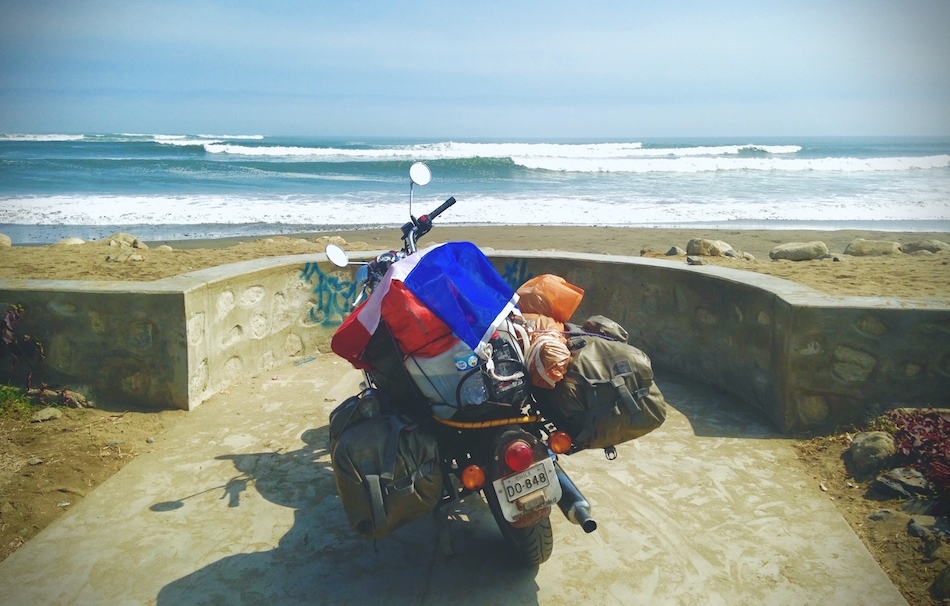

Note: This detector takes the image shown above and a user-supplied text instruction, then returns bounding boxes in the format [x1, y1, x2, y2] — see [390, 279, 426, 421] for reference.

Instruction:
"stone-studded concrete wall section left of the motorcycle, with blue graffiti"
[0, 255, 355, 410]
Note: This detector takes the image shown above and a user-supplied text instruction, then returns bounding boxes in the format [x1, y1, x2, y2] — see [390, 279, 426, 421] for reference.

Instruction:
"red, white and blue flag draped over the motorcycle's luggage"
[330, 242, 518, 368]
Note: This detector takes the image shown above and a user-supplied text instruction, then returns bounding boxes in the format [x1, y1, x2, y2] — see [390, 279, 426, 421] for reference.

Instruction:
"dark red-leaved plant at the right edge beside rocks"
[885, 408, 950, 499]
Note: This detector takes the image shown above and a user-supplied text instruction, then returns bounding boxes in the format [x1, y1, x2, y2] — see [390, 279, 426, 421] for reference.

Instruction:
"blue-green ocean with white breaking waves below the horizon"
[0, 134, 950, 244]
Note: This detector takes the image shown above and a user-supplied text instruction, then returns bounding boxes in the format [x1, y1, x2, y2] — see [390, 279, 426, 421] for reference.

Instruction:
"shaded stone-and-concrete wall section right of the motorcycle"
[491, 251, 950, 431]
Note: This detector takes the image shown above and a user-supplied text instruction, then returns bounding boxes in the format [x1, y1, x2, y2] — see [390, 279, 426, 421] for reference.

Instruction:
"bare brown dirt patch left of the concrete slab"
[0, 408, 187, 561]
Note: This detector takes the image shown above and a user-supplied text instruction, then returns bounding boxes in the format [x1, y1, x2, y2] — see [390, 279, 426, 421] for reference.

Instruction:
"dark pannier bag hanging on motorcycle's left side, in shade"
[330, 391, 443, 539]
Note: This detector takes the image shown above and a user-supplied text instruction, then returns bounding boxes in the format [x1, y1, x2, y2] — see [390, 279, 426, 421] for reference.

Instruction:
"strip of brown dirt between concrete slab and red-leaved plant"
[795, 433, 950, 606]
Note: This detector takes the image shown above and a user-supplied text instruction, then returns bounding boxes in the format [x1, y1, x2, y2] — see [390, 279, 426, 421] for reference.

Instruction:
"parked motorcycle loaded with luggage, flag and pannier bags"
[327, 162, 665, 565]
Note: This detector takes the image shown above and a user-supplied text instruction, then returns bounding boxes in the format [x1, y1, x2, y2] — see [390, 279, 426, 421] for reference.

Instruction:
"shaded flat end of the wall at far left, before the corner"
[0, 280, 188, 408]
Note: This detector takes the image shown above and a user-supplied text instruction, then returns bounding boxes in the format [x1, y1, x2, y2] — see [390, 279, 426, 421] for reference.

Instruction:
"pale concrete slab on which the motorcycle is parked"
[0, 356, 906, 606]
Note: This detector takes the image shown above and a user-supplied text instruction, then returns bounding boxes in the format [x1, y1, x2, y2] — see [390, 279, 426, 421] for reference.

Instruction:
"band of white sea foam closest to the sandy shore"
[0, 193, 950, 226]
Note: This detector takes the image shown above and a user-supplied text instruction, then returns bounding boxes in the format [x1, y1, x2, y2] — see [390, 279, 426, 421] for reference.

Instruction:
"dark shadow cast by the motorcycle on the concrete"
[156, 427, 538, 605]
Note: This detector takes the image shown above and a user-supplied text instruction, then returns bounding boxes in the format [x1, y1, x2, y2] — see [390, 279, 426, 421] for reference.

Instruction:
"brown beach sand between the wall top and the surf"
[0, 226, 950, 298]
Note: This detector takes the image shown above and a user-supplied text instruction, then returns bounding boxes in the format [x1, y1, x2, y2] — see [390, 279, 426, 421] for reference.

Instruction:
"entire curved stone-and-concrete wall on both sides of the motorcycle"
[0, 251, 950, 431]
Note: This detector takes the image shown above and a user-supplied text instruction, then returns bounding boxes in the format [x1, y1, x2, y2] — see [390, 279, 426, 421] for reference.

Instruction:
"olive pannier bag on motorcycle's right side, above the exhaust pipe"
[533, 325, 666, 450]
